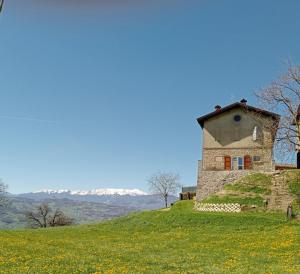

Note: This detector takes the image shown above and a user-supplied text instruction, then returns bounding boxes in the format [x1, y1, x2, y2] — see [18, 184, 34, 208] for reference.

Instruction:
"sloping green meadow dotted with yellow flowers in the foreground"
[0, 202, 300, 273]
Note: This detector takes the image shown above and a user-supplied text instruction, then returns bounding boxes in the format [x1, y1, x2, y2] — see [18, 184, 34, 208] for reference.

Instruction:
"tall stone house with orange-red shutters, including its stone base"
[197, 99, 280, 201]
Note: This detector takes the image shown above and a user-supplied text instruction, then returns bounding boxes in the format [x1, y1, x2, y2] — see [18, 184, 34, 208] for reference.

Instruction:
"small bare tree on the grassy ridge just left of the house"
[148, 171, 180, 208]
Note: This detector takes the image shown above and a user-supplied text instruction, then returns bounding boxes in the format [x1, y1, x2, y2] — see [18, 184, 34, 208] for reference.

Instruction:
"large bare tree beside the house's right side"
[255, 66, 300, 162]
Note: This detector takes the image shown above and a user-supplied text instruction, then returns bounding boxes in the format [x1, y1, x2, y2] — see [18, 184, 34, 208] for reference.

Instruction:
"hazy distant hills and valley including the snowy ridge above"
[0, 188, 177, 229]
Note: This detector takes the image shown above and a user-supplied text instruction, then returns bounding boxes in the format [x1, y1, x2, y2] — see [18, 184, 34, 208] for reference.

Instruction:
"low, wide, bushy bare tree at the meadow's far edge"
[26, 203, 73, 228]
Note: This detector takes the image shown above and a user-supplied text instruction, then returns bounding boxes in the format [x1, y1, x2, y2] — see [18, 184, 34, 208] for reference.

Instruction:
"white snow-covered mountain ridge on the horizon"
[33, 188, 148, 196]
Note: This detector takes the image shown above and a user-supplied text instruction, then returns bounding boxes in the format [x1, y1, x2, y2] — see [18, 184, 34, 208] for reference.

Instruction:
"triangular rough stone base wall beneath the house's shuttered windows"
[196, 170, 253, 201]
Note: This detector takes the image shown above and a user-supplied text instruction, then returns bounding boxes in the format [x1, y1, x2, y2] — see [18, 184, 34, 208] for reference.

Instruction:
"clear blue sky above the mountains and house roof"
[0, 0, 300, 193]
